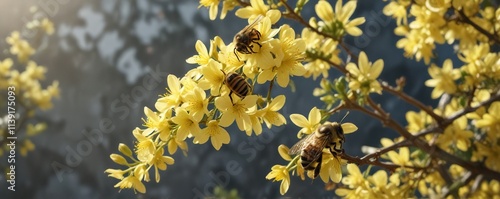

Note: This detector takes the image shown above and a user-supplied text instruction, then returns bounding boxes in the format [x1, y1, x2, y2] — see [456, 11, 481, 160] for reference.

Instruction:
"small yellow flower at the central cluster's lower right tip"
[259, 95, 286, 129]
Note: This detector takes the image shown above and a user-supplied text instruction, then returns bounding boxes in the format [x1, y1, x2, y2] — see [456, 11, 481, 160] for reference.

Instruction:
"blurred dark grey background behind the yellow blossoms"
[0, 0, 438, 199]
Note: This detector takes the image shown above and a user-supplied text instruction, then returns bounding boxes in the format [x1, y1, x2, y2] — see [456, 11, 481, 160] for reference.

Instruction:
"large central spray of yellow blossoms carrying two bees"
[106, 1, 305, 193]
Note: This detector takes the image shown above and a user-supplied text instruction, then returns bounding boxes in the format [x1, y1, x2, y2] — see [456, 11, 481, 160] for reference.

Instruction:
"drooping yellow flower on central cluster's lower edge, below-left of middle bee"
[193, 120, 231, 150]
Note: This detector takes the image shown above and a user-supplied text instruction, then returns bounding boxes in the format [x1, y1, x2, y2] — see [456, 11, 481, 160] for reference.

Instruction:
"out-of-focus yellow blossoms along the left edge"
[0, 18, 59, 159]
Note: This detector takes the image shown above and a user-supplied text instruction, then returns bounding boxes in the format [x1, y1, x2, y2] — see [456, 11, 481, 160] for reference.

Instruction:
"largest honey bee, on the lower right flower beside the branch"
[288, 122, 345, 178]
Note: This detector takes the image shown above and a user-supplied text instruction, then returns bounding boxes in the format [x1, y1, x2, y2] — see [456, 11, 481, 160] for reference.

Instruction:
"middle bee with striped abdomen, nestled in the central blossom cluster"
[222, 71, 252, 102]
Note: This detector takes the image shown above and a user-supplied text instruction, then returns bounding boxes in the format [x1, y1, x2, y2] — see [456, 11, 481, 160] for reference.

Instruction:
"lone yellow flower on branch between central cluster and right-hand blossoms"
[346, 52, 384, 95]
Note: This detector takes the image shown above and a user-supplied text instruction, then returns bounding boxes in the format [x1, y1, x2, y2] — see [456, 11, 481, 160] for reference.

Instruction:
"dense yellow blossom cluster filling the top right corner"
[383, 0, 500, 64]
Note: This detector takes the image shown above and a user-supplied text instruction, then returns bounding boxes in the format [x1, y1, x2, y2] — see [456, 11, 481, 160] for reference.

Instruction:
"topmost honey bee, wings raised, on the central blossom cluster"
[233, 15, 263, 61]
